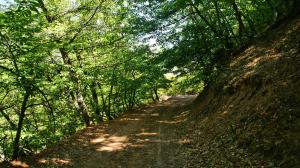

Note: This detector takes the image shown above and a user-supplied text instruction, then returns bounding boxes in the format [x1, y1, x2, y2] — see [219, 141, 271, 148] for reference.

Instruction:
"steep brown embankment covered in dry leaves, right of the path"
[186, 17, 300, 167]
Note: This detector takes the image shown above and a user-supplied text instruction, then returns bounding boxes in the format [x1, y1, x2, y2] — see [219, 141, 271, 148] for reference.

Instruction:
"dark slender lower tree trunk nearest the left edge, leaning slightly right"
[12, 91, 31, 160]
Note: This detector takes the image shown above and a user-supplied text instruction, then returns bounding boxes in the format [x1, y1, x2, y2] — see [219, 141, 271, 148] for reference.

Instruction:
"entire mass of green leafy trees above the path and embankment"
[0, 0, 298, 159]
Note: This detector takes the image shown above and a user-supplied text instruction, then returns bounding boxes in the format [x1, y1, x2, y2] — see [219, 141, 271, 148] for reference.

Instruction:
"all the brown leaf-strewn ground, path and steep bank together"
[4, 13, 300, 168]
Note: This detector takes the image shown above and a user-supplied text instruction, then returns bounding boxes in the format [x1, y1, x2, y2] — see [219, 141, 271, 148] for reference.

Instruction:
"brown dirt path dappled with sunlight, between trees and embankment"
[17, 96, 195, 168]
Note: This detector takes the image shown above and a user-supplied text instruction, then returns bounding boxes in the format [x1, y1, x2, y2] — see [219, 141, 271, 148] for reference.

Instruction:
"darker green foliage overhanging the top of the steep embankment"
[133, 0, 299, 85]
